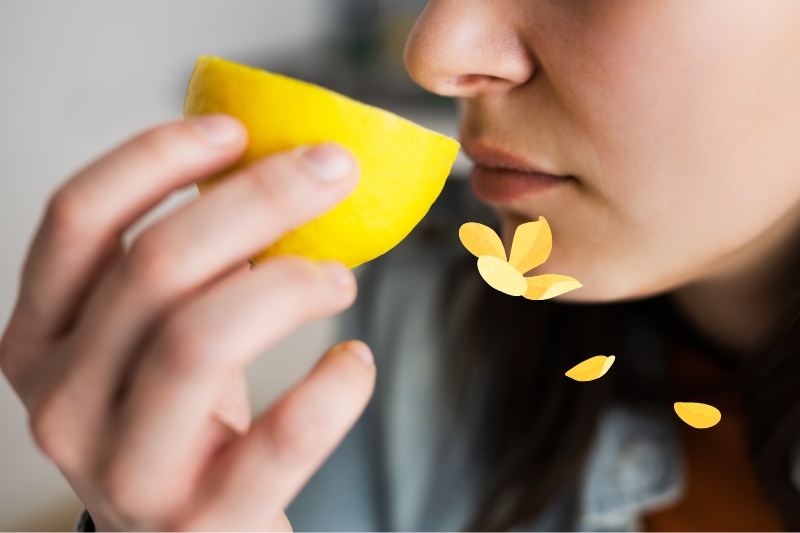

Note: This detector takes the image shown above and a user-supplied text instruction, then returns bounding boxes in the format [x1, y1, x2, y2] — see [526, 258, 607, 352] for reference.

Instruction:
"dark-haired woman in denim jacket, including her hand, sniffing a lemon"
[0, 0, 800, 530]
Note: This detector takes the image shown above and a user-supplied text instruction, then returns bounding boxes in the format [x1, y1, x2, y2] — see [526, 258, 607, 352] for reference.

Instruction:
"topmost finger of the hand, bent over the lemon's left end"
[12, 115, 247, 338]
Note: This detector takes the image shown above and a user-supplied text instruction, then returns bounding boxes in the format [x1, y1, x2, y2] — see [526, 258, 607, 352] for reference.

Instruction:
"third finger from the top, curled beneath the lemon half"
[100, 257, 355, 514]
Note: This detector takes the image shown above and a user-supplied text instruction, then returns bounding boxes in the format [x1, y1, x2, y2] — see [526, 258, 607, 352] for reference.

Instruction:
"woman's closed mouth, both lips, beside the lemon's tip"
[463, 143, 575, 204]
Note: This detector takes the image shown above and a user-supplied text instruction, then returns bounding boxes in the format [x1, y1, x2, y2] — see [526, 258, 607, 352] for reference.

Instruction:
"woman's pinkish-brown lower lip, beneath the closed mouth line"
[469, 165, 570, 204]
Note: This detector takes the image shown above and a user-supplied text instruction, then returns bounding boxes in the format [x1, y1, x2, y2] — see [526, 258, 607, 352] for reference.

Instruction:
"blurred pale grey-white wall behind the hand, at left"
[0, 0, 335, 530]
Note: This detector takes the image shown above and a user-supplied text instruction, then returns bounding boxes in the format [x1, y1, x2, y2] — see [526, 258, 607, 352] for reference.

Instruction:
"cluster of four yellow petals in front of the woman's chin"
[458, 217, 583, 300]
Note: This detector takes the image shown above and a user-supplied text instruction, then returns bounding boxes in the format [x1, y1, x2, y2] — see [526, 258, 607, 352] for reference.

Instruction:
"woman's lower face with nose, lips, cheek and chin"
[406, 0, 800, 301]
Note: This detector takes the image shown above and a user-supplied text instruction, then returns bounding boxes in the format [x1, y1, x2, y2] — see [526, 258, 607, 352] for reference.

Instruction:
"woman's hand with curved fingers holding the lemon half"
[0, 115, 375, 530]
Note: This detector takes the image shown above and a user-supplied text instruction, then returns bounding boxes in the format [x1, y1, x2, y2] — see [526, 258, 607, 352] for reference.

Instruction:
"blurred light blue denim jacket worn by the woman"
[287, 182, 800, 531]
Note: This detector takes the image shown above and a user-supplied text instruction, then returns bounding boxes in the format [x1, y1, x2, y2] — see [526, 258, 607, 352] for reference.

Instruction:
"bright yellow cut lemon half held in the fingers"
[184, 56, 459, 268]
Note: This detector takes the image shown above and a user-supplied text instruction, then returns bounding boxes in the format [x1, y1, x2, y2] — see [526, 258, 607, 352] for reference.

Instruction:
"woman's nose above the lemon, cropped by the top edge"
[405, 0, 536, 97]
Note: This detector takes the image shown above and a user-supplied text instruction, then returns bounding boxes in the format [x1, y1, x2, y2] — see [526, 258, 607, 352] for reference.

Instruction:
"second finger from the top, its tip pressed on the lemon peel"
[42, 144, 358, 458]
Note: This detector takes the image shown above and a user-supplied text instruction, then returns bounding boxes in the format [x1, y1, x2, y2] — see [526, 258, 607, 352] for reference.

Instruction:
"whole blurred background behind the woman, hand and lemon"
[0, 0, 466, 531]
